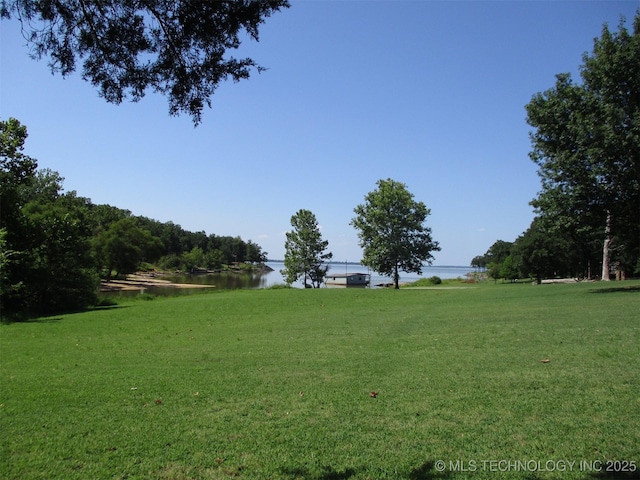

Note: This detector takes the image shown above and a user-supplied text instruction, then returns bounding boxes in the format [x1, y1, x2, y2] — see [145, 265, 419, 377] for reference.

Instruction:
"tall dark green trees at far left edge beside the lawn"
[0, 118, 98, 319]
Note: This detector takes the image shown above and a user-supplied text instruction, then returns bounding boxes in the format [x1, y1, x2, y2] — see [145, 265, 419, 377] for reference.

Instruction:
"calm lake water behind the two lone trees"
[160, 262, 474, 293]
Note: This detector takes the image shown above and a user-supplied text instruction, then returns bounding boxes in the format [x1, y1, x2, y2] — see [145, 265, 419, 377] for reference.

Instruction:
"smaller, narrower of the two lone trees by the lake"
[281, 209, 333, 288]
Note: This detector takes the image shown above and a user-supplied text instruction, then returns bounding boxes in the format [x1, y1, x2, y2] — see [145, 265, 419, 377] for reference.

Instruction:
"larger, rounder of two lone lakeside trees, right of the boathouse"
[351, 179, 440, 288]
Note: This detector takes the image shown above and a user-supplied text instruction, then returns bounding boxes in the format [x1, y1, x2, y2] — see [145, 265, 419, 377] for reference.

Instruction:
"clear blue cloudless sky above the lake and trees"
[0, 0, 640, 265]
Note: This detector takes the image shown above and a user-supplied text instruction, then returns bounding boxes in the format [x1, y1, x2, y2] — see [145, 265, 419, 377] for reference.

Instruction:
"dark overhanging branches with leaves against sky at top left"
[0, 0, 289, 124]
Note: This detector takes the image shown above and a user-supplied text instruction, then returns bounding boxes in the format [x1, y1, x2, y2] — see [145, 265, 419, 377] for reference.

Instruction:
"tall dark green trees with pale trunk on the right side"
[472, 12, 640, 281]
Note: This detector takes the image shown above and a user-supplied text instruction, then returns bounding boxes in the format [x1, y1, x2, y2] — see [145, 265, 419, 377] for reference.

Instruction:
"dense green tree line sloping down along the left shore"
[0, 118, 267, 319]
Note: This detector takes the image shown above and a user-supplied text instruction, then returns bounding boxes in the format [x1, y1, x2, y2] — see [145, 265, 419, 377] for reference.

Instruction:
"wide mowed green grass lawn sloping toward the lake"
[0, 282, 640, 480]
